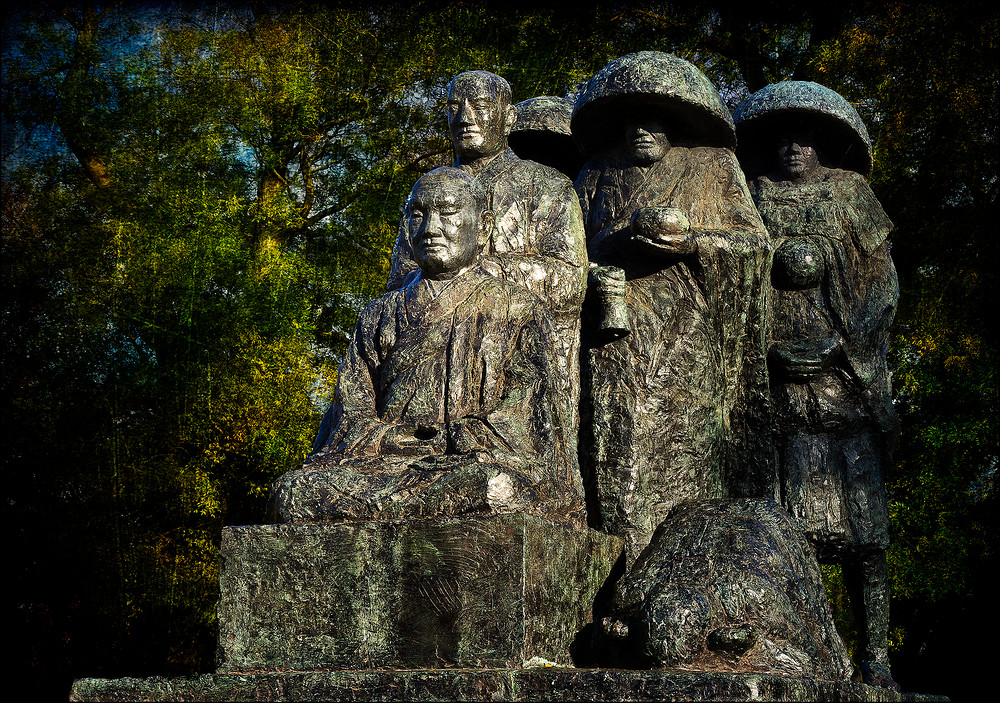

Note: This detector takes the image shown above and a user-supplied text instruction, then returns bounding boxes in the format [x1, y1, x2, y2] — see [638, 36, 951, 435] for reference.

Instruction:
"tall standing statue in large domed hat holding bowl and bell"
[572, 52, 769, 561]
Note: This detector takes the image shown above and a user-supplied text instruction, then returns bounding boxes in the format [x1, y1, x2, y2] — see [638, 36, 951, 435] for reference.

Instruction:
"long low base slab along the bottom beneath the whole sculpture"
[70, 668, 948, 703]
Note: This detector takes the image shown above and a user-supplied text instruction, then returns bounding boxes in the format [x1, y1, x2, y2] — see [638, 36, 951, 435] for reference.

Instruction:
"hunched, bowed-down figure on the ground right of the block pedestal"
[605, 500, 852, 681]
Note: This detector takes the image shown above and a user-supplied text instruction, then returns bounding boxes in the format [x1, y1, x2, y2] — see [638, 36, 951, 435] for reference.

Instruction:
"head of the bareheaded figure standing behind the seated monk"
[448, 73, 517, 159]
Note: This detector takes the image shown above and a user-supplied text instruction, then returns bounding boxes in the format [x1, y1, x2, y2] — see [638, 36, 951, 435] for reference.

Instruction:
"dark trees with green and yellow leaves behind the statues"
[0, 0, 1000, 700]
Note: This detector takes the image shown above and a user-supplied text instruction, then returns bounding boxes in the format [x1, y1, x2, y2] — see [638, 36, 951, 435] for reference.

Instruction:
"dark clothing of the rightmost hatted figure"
[751, 167, 899, 557]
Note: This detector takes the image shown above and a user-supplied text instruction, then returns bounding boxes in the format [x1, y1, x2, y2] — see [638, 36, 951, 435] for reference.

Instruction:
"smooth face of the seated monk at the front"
[407, 174, 480, 279]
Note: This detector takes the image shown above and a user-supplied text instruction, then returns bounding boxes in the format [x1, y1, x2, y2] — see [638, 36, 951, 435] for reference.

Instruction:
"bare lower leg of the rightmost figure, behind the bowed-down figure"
[844, 550, 899, 690]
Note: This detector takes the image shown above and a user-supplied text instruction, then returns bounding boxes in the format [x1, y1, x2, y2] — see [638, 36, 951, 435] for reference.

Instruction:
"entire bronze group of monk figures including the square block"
[68, 52, 898, 695]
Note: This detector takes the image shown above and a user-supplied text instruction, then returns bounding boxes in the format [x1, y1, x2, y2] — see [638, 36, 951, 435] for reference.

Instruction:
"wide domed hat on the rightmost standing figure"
[734, 81, 872, 177]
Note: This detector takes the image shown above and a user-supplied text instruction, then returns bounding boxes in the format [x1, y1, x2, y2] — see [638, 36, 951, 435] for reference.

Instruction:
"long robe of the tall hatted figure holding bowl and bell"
[576, 147, 774, 560]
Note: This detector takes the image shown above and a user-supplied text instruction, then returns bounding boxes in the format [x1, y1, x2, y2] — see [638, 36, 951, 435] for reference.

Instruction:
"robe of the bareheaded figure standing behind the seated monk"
[386, 149, 587, 446]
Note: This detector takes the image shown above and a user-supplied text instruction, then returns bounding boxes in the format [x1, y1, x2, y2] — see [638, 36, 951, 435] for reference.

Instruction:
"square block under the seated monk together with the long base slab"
[70, 515, 948, 702]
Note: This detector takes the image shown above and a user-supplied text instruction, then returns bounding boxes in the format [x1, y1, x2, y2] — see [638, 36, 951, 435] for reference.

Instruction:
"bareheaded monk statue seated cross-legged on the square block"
[268, 168, 585, 526]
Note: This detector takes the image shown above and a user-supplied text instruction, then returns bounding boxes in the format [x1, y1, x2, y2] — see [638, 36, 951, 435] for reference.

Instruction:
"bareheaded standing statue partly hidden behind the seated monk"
[387, 71, 587, 456]
